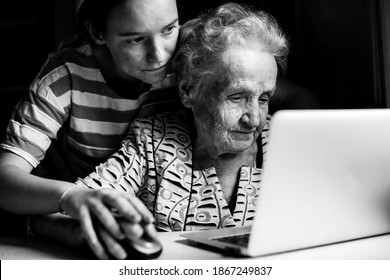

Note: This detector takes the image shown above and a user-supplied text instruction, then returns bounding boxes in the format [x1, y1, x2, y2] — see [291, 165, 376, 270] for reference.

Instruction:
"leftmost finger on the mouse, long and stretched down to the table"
[80, 206, 108, 259]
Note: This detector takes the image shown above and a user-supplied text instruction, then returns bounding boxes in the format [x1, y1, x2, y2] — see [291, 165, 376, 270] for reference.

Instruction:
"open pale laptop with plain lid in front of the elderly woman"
[181, 109, 390, 257]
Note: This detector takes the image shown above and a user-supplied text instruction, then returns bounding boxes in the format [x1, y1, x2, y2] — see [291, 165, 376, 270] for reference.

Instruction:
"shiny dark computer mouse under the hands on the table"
[119, 233, 163, 260]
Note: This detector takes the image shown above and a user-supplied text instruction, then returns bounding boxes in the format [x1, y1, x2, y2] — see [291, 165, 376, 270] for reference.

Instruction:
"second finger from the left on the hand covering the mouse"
[88, 200, 125, 239]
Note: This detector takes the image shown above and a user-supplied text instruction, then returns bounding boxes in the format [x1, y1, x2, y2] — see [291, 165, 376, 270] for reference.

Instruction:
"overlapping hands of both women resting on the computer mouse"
[61, 187, 155, 259]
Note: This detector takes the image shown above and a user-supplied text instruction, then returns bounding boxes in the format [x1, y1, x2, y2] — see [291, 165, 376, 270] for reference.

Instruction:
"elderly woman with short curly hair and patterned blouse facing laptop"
[74, 3, 288, 231]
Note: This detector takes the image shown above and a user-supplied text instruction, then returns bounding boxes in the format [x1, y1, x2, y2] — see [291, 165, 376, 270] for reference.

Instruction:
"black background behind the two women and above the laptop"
[0, 0, 389, 136]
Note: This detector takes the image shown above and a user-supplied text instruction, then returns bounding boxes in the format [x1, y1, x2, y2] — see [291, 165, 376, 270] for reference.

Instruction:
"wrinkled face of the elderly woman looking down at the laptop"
[193, 41, 277, 156]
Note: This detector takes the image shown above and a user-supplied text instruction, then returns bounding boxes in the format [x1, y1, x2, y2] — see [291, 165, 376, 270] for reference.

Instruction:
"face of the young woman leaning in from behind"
[103, 0, 179, 84]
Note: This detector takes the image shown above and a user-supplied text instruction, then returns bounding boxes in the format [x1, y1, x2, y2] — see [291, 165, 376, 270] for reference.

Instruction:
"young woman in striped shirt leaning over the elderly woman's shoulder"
[0, 0, 179, 258]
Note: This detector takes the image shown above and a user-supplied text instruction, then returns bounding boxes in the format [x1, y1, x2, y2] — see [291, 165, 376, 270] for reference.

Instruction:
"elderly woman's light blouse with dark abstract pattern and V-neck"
[76, 111, 269, 231]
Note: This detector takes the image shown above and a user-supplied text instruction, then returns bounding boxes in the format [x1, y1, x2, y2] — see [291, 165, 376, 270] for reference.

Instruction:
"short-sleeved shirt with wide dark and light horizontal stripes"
[1, 45, 177, 177]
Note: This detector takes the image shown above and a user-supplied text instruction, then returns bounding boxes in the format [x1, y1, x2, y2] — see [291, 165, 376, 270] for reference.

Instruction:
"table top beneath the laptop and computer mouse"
[0, 232, 390, 260]
